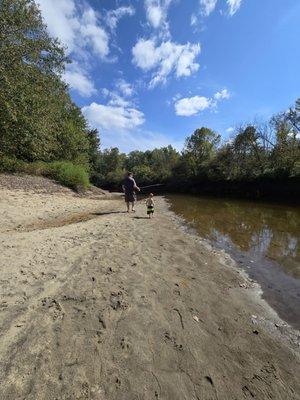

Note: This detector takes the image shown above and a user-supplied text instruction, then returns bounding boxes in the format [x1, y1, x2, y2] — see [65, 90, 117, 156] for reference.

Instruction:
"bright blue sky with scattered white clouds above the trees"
[36, 0, 300, 152]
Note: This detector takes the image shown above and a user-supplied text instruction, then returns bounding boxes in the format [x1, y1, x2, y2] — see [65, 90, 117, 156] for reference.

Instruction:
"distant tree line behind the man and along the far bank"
[92, 99, 300, 192]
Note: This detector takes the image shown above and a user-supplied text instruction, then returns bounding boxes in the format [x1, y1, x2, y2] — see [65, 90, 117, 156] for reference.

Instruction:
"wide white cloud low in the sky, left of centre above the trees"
[82, 102, 145, 132]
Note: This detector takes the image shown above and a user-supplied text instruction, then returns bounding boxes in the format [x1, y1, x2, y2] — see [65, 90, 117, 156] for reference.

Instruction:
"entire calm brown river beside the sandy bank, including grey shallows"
[167, 195, 300, 329]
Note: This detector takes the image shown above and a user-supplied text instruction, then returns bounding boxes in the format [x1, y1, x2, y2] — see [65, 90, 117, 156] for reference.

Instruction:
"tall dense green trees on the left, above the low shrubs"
[0, 0, 99, 167]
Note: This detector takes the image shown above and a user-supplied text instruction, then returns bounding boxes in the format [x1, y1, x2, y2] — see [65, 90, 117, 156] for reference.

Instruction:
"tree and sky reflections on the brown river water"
[170, 195, 300, 278]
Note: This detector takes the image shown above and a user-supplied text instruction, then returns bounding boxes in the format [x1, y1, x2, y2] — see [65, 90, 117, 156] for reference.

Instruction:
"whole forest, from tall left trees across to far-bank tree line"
[0, 0, 300, 197]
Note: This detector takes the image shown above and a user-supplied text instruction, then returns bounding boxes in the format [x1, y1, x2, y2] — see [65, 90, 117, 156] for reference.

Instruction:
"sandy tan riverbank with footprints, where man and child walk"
[0, 177, 300, 400]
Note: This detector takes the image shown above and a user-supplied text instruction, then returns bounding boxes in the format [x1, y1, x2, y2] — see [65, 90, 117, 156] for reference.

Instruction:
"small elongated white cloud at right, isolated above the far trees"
[175, 89, 230, 117]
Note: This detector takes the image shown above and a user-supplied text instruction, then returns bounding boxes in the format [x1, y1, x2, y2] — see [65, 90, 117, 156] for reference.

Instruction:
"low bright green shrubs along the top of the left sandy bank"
[0, 156, 90, 191]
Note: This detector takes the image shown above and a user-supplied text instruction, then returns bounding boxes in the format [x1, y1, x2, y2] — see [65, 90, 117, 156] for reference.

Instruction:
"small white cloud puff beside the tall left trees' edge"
[63, 63, 97, 97]
